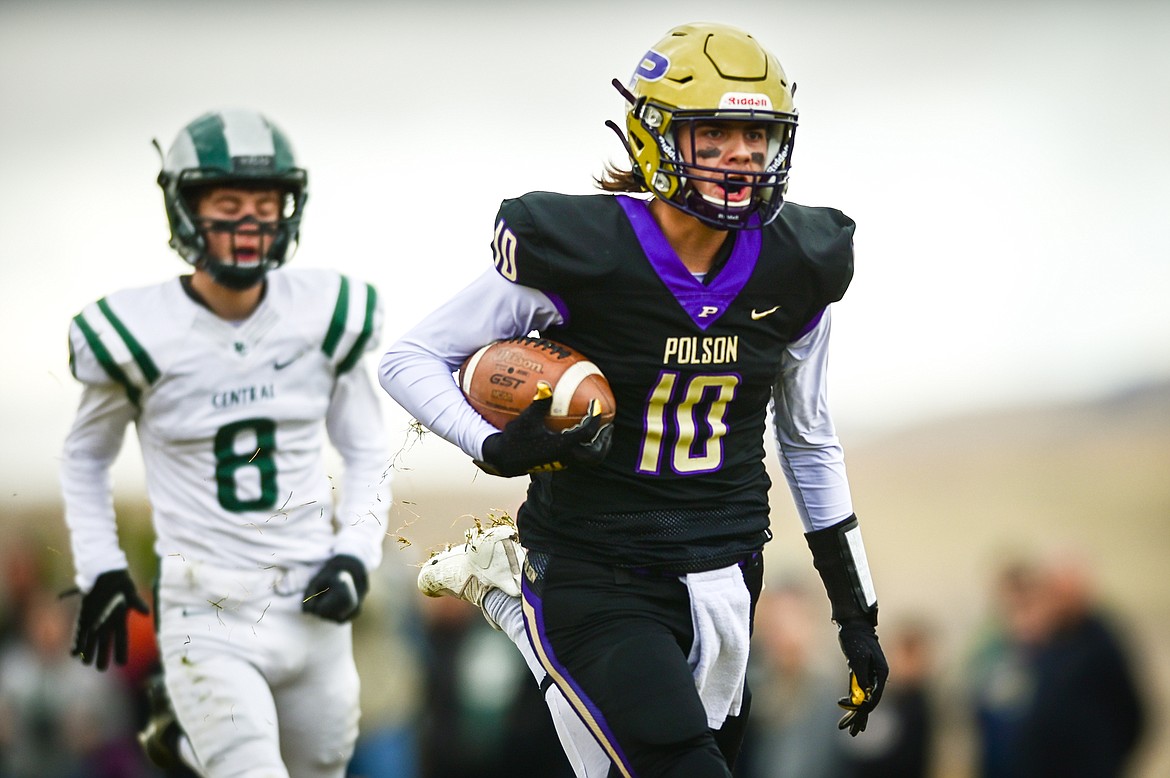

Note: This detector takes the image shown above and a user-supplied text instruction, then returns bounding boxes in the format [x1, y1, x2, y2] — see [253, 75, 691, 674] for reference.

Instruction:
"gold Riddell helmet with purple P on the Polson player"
[626, 23, 797, 229]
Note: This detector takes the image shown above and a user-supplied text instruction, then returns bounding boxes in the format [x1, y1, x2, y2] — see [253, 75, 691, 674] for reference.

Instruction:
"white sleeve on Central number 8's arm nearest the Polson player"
[325, 359, 391, 571]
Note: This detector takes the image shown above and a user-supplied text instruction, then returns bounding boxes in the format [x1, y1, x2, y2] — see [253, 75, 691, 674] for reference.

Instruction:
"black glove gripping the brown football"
[475, 381, 613, 477]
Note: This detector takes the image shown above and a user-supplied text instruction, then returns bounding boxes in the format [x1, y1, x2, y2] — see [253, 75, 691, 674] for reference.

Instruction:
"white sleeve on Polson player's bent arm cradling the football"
[378, 269, 563, 459]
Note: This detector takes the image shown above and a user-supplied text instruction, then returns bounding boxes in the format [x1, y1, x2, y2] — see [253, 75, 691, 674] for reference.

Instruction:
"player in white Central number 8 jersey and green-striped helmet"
[61, 110, 390, 778]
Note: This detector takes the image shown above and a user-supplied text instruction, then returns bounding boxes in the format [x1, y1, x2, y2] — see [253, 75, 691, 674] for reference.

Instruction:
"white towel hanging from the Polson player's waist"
[682, 565, 751, 729]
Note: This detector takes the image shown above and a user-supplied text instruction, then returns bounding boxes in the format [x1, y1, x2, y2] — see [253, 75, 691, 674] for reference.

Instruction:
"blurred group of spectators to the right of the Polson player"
[737, 552, 1149, 778]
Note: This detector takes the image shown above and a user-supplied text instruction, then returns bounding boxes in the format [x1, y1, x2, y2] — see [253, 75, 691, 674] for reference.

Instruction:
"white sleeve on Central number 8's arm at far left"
[61, 384, 137, 592]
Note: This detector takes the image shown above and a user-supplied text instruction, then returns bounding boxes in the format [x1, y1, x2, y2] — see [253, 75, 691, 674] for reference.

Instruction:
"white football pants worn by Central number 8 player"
[158, 557, 359, 778]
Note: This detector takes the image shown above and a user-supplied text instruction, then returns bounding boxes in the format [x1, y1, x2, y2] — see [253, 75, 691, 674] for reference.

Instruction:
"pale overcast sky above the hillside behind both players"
[0, 0, 1170, 496]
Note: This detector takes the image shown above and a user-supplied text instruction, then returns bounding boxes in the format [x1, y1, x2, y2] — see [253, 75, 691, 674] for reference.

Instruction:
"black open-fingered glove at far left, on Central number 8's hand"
[70, 570, 150, 670]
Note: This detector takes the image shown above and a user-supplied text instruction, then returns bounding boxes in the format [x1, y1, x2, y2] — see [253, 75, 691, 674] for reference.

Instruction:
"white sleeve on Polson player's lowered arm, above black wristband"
[772, 309, 853, 532]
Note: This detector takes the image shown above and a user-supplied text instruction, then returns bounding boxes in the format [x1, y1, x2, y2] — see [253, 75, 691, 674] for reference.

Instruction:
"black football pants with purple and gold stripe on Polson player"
[524, 555, 763, 778]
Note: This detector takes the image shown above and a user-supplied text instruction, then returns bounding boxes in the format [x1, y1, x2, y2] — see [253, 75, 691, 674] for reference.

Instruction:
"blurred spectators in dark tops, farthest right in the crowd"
[968, 551, 1149, 777]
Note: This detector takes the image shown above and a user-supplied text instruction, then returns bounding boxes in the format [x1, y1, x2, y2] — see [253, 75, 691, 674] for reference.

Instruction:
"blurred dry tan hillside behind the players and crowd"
[0, 385, 1170, 778]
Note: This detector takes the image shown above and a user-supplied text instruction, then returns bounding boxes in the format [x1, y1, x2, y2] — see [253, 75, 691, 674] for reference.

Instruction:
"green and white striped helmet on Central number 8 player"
[156, 110, 309, 289]
